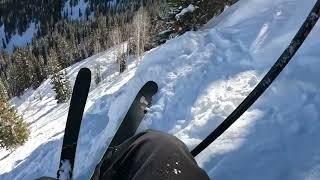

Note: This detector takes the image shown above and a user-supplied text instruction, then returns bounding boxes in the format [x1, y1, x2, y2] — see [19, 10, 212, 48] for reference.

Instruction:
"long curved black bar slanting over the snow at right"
[191, 0, 320, 156]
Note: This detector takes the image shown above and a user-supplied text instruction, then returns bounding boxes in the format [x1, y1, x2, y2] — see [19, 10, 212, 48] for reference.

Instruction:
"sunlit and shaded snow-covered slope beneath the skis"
[0, 0, 320, 180]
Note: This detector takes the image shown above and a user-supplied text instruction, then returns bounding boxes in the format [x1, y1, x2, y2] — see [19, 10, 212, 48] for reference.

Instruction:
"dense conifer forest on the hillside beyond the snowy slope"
[0, 0, 234, 97]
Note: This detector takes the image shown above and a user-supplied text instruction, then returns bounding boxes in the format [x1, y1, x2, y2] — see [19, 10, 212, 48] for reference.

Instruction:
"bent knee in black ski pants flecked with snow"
[92, 130, 209, 180]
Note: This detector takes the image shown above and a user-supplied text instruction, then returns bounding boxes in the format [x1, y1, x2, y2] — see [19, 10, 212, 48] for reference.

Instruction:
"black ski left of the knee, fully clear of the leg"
[57, 68, 91, 180]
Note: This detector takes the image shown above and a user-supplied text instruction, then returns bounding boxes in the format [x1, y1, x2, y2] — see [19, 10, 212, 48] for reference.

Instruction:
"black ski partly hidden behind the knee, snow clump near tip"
[91, 81, 158, 179]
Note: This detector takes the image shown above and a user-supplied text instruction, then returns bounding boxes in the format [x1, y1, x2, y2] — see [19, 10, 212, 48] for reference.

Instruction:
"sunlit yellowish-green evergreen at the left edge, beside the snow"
[0, 81, 30, 150]
